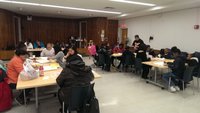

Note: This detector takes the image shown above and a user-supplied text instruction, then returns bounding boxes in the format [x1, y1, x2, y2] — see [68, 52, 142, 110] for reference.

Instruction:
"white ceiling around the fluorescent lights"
[0, 0, 200, 19]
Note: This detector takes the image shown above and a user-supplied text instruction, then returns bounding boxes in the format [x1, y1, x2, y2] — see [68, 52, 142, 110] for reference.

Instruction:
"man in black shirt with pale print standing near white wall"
[132, 35, 144, 52]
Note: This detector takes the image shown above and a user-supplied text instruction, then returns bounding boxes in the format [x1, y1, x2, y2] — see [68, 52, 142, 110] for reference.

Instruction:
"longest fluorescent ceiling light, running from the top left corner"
[0, 0, 121, 14]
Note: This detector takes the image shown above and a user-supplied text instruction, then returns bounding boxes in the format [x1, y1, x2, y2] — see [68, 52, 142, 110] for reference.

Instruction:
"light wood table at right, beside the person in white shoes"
[142, 58, 174, 89]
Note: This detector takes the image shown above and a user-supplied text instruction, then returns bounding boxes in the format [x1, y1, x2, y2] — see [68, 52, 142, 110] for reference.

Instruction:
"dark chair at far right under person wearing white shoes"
[168, 66, 196, 93]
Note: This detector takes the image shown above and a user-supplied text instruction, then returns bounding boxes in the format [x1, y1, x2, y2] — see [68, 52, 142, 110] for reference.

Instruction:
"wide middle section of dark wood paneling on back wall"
[21, 17, 79, 43]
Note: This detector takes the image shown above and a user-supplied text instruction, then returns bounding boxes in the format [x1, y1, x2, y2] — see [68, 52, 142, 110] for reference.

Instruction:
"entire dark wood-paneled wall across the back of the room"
[0, 9, 118, 50]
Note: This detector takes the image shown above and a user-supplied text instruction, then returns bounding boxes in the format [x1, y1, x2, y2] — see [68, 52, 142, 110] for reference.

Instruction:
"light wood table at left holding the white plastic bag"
[17, 64, 101, 109]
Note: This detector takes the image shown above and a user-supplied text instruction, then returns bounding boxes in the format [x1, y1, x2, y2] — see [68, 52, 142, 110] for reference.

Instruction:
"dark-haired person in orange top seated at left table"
[7, 49, 30, 105]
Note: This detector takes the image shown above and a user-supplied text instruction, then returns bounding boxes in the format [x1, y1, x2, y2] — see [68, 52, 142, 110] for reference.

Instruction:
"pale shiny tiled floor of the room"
[5, 58, 200, 113]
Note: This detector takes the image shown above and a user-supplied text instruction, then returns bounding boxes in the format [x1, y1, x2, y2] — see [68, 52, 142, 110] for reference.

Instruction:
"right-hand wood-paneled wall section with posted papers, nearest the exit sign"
[81, 17, 118, 45]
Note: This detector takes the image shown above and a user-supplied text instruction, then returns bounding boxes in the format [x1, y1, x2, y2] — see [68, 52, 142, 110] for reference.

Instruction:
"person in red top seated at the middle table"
[111, 44, 124, 68]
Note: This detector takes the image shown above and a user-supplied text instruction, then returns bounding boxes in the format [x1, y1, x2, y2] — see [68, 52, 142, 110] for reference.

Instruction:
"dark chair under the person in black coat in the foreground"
[62, 85, 91, 113]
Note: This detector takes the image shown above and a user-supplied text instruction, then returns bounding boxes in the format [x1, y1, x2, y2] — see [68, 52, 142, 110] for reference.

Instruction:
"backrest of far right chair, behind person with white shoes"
[183, 66, 196, 83]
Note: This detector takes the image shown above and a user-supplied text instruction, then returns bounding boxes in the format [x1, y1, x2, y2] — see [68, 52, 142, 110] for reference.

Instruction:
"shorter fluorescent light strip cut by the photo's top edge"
[110, 0, 156, 6]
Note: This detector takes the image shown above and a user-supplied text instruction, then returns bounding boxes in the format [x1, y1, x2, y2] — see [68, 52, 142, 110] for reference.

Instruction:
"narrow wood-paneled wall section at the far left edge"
[0, 9, 15, 50]
